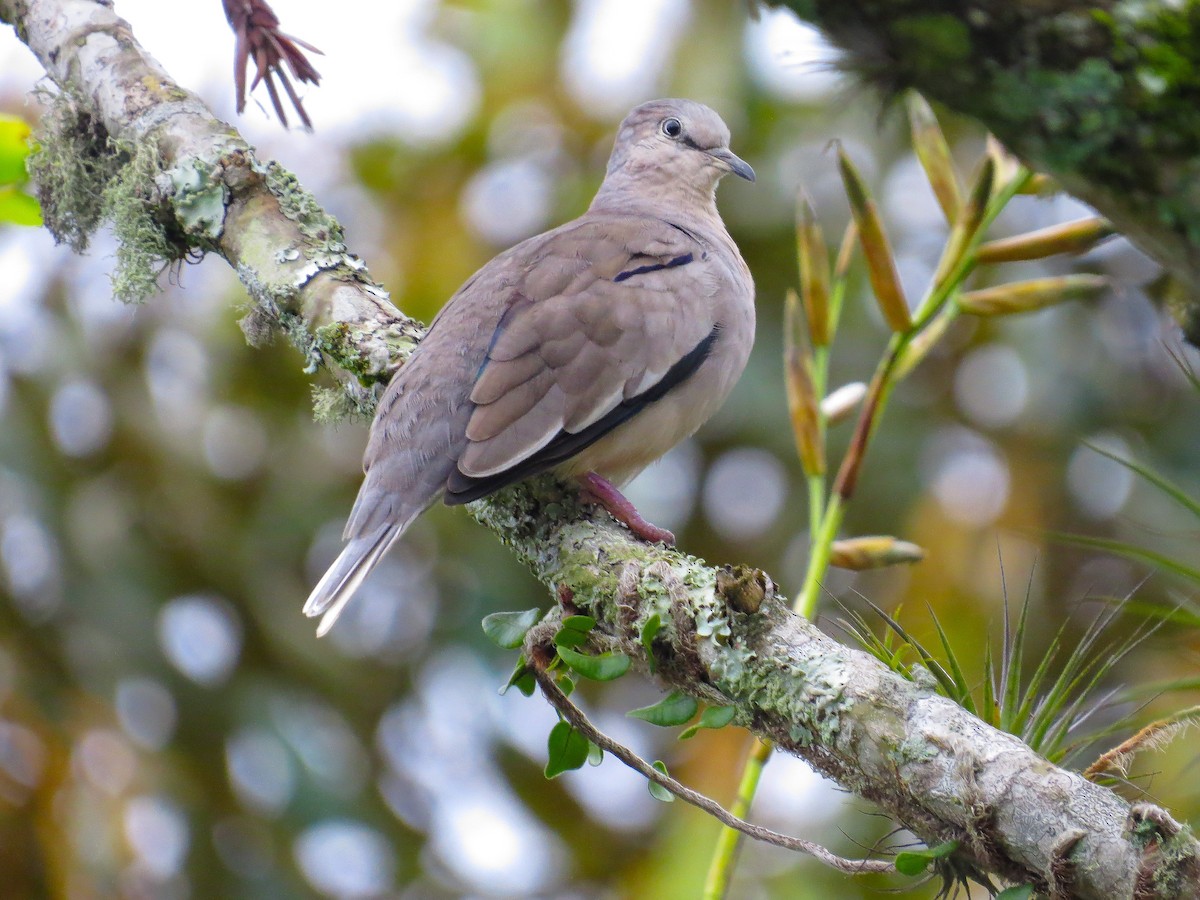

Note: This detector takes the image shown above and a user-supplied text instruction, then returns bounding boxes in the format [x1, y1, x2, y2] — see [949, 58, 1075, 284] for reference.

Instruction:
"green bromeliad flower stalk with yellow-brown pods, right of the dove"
[704, 95, 1114, 899]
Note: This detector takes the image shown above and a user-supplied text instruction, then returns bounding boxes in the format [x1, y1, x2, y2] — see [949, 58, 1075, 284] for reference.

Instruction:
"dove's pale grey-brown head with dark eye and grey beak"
[605, 100, 754, 207]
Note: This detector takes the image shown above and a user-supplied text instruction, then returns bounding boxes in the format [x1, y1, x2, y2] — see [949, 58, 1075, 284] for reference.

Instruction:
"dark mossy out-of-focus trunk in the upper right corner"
[772, 0, 1200, 346]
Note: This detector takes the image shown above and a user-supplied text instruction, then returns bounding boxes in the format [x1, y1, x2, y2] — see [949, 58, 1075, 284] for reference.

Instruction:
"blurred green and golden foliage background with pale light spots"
[0, 0, 1200, 898]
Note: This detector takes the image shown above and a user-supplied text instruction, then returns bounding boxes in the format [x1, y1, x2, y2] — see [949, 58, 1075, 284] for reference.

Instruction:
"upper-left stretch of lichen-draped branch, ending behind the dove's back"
[0, 0, 421, 413]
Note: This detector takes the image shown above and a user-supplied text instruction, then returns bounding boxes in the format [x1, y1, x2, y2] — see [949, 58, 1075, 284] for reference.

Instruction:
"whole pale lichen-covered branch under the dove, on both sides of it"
[0, 0, 1200, 900]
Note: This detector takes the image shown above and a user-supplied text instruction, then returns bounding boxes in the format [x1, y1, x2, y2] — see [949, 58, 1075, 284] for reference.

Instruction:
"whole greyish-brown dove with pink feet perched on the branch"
[304, 100, 755, 636]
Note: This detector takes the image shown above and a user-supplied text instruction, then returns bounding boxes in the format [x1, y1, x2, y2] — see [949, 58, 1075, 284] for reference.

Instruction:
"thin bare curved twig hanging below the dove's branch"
[533, 665, 895, 875]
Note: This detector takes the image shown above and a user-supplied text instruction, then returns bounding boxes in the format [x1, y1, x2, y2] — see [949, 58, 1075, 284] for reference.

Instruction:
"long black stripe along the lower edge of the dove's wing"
[445, 324, 721, 506]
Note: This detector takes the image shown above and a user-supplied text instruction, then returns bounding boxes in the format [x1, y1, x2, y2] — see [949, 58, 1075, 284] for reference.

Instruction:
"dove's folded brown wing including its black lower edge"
[446, 215, 730, 504]
